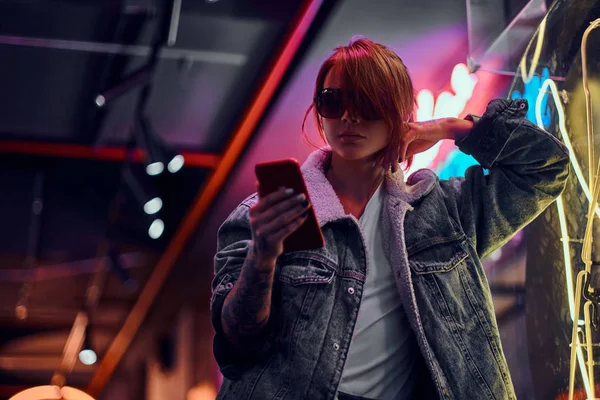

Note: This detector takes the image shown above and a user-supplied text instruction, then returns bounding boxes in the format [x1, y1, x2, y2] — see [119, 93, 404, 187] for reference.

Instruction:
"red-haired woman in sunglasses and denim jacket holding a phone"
[212, 39, 568, 400]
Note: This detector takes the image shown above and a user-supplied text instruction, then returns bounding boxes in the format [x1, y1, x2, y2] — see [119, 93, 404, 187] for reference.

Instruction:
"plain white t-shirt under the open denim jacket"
[338, 185, 417, 400]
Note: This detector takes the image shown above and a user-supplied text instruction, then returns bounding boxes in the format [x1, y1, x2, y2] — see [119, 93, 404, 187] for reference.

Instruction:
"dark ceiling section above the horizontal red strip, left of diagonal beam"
[0, 0, 301, 148]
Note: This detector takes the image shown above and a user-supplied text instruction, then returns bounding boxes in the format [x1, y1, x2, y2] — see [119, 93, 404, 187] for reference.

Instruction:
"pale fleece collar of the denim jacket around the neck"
[302, 147, 437, 226]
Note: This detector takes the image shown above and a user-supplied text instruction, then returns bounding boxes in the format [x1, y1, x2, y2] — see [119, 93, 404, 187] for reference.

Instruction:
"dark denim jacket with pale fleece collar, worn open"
[211, 100, 569, 400]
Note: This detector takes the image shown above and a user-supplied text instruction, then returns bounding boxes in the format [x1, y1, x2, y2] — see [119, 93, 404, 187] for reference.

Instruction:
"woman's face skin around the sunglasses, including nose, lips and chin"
[323, 73, 390, 161]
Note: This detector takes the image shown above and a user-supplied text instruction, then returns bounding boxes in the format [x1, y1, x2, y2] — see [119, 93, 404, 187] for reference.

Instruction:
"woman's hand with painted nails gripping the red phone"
[250, 188, 311, 266]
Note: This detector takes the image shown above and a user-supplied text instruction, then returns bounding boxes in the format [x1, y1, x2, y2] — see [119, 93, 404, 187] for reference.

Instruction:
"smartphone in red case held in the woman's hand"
[254, 158, 325, 252]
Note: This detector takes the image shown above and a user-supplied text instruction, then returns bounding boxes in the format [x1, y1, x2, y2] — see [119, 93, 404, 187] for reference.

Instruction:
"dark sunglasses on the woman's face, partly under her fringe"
[314, 88, 382, 121]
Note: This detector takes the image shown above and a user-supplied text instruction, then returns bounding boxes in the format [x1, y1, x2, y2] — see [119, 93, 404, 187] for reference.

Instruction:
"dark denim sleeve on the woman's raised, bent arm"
[440, 99, 569, 258]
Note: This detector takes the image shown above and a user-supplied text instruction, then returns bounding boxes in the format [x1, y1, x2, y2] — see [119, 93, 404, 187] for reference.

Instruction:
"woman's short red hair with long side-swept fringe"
[302, 38, 416, 167]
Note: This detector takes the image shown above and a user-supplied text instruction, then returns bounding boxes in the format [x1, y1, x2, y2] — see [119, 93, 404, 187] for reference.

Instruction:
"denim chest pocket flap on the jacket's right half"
[408, 237, 469, 275]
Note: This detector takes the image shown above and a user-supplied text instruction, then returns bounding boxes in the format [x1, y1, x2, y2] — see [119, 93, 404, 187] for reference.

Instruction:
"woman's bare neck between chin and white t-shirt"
[326, 153, 383, 203]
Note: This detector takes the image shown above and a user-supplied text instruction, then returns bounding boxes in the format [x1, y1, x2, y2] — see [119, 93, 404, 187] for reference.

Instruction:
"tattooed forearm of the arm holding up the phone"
[222, 257, 273, 338]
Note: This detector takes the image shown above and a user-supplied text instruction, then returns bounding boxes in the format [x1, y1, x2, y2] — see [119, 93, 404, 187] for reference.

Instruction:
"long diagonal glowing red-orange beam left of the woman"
[87, 0, 322, 397]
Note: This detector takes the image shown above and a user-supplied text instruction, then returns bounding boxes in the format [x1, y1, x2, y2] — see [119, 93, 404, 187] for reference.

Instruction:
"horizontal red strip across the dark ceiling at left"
[0, 140, 221, 168]
